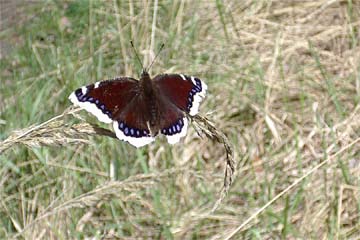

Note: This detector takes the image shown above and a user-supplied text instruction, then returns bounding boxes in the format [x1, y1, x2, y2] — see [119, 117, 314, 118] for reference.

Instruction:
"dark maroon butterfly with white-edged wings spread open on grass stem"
[69, 46, 207, 147]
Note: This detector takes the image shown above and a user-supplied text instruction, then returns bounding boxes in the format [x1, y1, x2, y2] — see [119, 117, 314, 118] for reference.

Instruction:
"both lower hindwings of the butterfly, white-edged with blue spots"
[114, 90, 187, 147]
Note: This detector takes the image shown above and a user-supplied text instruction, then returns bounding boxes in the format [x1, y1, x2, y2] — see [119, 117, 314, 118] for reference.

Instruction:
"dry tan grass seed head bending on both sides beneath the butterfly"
[0, 108, 235, 211]
